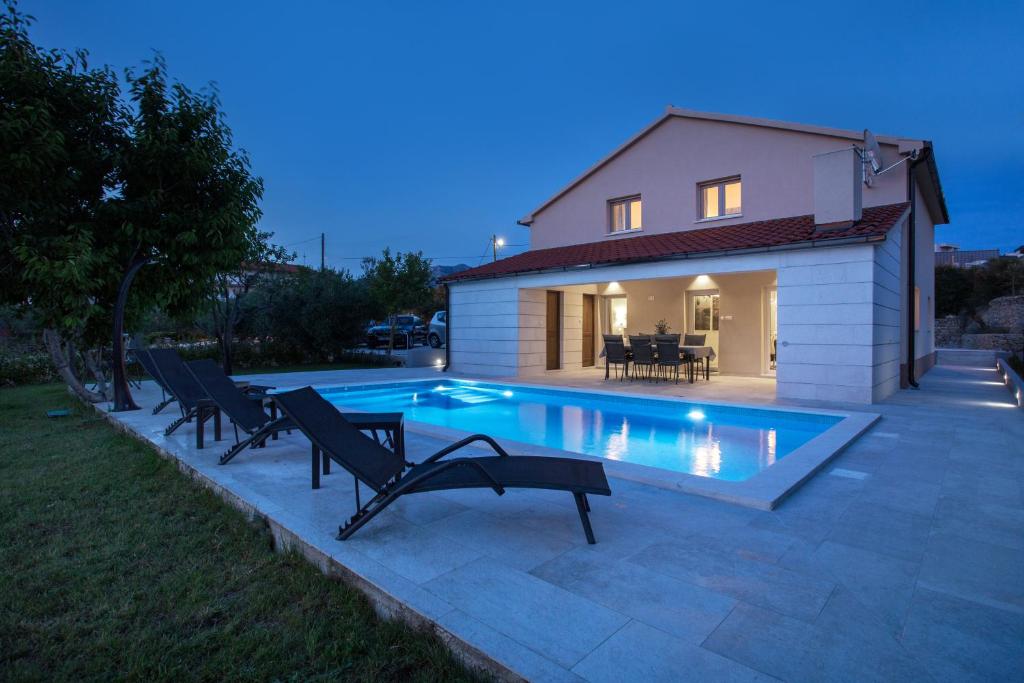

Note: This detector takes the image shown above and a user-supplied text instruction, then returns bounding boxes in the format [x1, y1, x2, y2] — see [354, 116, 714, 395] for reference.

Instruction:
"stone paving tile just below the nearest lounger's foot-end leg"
[530, 548, 736, 645]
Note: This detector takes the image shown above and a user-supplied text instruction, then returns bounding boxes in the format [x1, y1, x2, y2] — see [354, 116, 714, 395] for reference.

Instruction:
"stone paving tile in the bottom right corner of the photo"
[902, 588, 1024, 682]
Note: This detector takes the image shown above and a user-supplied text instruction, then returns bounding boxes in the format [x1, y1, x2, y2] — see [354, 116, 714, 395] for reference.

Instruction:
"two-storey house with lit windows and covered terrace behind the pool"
[436, 106, 948, 403]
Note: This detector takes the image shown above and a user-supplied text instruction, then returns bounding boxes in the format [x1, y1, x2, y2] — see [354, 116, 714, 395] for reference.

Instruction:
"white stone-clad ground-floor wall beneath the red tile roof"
[450, 237, 903, 403]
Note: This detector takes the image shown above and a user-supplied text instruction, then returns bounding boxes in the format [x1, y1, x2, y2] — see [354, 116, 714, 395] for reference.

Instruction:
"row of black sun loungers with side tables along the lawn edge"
[132, 349, 611, 544]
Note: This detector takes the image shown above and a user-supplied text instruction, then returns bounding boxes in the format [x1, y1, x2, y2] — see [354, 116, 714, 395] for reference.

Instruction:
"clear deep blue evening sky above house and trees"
[22, 0, 1024, 269]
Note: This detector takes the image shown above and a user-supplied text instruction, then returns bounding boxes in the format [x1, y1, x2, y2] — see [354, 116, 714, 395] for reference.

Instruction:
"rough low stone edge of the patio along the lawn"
[92, 403, 526, 683]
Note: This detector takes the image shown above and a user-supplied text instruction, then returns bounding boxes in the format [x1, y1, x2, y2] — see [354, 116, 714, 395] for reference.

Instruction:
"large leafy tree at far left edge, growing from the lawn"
[0, 1, 127, 400]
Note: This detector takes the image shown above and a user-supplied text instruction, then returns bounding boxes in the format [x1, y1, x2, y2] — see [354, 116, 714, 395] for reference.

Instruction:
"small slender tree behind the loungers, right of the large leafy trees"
[198, 232, 295, 375]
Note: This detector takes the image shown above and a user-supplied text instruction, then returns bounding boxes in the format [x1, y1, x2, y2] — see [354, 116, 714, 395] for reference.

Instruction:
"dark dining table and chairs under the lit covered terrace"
[601, 335, 715, 384]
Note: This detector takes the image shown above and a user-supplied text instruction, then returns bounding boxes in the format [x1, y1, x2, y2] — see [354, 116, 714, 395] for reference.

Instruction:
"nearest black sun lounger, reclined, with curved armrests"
[274, 387, 611, 543]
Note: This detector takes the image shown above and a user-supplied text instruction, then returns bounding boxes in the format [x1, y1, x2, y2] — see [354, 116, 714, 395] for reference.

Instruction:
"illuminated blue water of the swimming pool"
[319, 380, 841, 481]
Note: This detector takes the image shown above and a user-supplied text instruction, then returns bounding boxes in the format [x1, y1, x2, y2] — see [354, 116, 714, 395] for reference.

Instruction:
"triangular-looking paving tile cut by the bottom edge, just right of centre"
[572, 622, 772, 683]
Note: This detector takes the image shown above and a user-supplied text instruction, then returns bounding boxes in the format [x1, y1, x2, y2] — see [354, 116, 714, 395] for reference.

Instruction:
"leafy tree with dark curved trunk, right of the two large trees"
[106, 55, 263, 411]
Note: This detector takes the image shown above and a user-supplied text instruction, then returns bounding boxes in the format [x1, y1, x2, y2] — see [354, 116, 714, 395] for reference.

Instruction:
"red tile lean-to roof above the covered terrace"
[442, 202, 909, 282]
